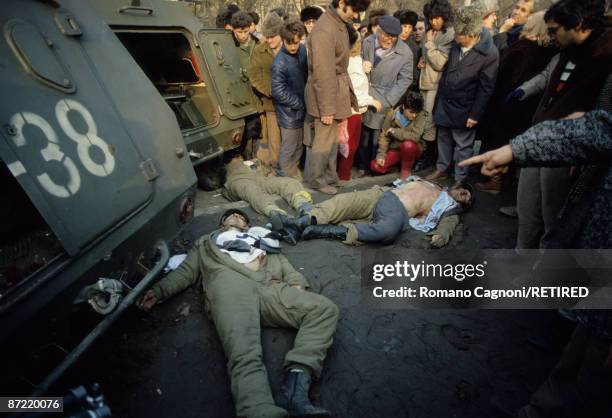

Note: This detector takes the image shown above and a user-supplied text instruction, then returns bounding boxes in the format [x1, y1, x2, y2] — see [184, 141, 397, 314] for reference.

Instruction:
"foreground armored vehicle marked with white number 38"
[0, 0, 196, 393]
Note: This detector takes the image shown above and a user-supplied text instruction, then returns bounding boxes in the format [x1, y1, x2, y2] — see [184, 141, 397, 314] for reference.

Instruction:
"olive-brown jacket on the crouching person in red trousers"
[376, 108, 435, 159]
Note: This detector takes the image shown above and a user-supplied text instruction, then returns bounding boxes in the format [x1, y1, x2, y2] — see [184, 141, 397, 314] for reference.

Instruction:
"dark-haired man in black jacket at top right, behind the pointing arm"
[516, 0, 612, 249]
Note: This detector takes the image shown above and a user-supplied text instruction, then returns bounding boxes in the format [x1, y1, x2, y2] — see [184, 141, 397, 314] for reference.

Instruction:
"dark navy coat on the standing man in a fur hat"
[433, 29, 499, 129]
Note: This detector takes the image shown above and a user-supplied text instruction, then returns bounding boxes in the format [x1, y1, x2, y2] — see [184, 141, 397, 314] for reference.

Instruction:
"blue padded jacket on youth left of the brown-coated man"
[271, 45, 308, 129]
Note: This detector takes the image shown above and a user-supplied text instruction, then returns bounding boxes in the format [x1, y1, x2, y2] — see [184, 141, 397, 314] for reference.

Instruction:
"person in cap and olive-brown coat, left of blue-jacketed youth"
[249, 12, 283, 170]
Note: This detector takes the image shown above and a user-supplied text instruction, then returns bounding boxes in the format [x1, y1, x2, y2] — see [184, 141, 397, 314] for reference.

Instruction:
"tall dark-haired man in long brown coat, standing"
[304, 0, 370, 194]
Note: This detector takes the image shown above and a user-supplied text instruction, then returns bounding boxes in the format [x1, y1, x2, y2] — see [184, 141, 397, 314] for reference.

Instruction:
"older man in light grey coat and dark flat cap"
[357, 16, 413, 175]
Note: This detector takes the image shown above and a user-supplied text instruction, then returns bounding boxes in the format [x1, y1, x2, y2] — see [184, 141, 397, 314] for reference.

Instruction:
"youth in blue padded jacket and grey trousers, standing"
[272, 19, 308, 179]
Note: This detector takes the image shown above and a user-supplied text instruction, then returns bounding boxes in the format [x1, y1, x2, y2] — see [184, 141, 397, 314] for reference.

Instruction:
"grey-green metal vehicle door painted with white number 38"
[0, 1, 157, 255]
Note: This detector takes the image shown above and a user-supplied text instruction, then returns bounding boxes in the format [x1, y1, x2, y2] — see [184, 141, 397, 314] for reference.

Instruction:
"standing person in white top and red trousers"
[338, 26, 382, 181]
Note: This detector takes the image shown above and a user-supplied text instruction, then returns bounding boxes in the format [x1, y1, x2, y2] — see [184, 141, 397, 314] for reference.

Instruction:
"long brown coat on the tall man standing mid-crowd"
[305, 6, 358, 120]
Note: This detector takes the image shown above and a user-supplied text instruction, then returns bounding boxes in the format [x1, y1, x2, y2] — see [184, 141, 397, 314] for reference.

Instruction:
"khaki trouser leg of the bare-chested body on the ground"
[310, 186, 386, 245]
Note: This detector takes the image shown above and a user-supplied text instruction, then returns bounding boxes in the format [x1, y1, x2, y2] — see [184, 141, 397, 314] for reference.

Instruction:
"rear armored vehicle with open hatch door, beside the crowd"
[88, 0, 256, 190]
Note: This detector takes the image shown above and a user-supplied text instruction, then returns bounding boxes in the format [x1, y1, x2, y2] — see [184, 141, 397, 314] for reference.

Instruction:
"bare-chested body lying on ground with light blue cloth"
[283, 176, 473, 247]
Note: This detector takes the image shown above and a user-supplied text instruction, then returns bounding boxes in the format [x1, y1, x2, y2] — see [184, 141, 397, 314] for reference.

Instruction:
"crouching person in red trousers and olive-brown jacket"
[370, 91, 428, 179]
